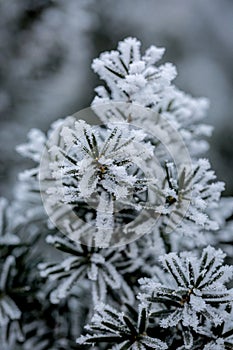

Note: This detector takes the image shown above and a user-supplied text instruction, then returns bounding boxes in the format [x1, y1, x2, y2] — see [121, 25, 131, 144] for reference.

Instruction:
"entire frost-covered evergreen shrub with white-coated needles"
[0, 38, 233, 350]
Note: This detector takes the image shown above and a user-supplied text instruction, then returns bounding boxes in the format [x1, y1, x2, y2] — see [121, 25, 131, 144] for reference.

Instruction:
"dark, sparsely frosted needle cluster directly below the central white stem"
[39, 236, 137, 303]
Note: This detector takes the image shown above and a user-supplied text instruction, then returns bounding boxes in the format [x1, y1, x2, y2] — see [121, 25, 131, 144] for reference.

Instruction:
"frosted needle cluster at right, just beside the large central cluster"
[157, 159, 224, 234]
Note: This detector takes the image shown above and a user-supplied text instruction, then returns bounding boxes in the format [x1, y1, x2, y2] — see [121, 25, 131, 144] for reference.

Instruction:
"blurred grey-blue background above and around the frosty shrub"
[0, 0, 233, 198]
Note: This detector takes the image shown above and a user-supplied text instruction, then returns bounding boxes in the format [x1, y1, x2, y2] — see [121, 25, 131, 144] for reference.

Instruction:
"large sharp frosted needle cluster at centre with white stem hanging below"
[44, 120, 156, 248]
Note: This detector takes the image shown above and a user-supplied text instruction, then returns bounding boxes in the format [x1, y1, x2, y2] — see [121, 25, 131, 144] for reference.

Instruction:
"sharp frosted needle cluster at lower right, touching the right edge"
[140, 246, 233, 332]
